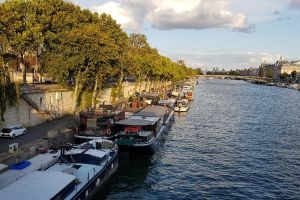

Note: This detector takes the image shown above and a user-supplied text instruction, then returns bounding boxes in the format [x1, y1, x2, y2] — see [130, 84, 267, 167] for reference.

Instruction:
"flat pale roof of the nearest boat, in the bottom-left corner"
[0, 171, 76, 200]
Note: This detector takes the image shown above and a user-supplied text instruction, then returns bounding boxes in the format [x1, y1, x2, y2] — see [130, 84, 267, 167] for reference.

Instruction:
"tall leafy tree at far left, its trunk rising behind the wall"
[0, 0, 47, 83]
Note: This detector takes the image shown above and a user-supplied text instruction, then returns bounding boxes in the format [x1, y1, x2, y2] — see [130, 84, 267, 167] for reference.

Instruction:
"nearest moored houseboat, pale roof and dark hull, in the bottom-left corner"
[0, 140, 118, 200]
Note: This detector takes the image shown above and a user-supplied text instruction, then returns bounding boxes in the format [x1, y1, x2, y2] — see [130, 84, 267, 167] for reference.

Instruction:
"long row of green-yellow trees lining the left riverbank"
[0, 0, 197, 109]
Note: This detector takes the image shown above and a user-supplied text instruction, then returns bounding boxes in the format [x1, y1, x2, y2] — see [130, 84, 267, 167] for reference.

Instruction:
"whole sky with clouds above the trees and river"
[59, 0, 300, 69]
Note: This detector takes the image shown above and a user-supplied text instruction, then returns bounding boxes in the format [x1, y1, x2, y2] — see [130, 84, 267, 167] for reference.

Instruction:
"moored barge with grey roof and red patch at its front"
[116, 106, 174, 150]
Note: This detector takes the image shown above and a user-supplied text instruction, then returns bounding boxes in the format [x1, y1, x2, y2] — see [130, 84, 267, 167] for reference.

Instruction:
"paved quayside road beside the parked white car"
[0, 116, 75, 153]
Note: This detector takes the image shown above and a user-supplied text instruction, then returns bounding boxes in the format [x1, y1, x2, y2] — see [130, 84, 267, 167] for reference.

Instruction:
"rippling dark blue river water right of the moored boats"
[95, 80, 300, 199]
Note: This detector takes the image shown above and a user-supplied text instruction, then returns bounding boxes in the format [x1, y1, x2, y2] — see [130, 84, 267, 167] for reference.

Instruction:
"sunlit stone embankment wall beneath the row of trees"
[0, 81, 172, 127]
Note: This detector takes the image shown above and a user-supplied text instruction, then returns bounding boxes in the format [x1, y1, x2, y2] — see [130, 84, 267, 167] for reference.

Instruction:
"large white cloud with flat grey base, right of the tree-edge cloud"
[148, 0, 254, 32]
